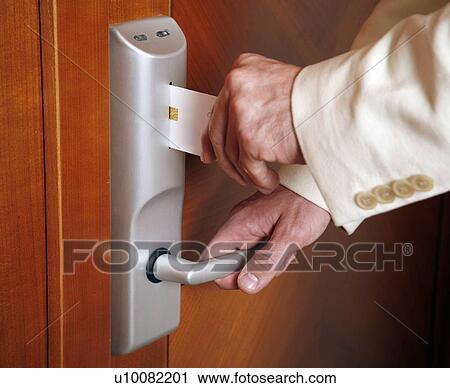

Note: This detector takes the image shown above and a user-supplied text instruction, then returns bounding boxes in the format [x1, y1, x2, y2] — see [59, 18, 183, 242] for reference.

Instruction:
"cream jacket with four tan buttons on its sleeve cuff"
[279, 0, 450, 233]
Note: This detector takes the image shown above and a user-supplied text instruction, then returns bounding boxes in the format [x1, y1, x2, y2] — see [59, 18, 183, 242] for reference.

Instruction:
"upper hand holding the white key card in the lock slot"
[201, 54, 304, 194]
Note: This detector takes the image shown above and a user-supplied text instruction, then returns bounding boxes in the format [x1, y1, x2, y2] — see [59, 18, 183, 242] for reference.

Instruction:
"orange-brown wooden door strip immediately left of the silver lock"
[41, 0, 169, 367]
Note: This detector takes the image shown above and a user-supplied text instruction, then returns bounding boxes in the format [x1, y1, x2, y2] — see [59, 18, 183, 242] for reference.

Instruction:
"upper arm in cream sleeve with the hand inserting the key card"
[203, 2, 450, 233]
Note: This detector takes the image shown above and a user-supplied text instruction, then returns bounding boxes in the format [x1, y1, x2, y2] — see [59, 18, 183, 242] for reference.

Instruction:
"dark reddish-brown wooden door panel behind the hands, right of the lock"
[169, 0, 440, 367]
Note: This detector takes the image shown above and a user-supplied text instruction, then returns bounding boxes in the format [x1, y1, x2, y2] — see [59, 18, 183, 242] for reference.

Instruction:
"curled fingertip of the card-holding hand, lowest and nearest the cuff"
[239, 154, 280, 194]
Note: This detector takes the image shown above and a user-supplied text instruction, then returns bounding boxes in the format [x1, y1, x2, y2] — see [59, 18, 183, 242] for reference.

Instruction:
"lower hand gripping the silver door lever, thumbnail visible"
[205, 186, 330, 294]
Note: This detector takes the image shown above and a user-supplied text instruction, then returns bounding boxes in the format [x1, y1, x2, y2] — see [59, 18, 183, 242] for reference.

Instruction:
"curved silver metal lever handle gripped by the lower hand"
[147, 251, 247, 285]
